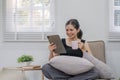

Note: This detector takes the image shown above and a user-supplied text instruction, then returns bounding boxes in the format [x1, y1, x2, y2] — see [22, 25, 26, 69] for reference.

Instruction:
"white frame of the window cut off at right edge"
[108, 0, 120, 41]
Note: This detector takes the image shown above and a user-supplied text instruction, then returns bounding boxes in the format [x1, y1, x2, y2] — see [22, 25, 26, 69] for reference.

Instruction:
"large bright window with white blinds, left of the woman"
[3, 0, 55, 41]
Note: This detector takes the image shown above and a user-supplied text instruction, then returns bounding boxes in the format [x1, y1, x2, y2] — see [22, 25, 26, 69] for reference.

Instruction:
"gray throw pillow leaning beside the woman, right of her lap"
[83, 52, 115, 79]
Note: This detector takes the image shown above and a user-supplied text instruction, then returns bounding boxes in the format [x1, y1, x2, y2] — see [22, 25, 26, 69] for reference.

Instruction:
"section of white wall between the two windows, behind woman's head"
[57, 0, 108, 40]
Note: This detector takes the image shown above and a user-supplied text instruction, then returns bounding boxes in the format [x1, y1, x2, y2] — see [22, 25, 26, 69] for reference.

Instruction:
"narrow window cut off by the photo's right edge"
[109, 0, 120, 41]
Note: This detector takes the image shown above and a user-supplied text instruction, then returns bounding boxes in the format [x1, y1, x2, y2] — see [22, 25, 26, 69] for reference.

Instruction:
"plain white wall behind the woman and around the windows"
[0, 0, 120, 80]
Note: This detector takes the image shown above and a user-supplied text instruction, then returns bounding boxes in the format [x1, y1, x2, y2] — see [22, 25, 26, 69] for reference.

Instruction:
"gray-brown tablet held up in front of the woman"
[47, 35, 66, 54]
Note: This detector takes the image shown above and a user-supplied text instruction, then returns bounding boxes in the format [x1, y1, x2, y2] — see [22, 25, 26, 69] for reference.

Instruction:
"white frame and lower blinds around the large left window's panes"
[2, 0, 56, 42]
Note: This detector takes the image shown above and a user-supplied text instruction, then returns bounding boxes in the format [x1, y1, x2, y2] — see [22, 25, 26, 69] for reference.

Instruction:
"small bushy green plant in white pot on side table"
[17, 55, 33, 66]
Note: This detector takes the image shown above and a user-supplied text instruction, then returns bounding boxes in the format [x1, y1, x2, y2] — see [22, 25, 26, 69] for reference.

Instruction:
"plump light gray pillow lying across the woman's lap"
[49, 56, 94, 75]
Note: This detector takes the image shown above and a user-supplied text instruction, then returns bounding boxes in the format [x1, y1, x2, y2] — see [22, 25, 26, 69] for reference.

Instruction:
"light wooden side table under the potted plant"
[3, 65, 44, 80]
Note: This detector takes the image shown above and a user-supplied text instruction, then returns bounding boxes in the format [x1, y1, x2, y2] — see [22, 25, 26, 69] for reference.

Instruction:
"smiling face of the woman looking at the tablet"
[66, 24, 79, 39]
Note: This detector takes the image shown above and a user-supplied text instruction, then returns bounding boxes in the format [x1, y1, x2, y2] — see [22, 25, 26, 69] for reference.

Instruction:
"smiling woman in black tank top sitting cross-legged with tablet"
[42, 19, 99, 80]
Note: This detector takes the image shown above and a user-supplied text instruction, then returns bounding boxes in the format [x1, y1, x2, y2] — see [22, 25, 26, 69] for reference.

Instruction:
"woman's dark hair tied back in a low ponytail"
[65, 19, 83, 39]
